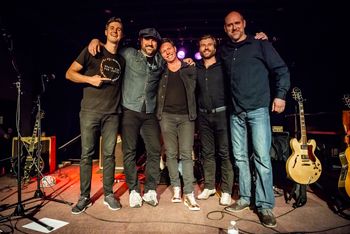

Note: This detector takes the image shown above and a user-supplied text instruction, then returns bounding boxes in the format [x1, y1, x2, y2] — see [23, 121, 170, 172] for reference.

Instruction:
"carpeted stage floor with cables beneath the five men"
[0, 163, 350, 233]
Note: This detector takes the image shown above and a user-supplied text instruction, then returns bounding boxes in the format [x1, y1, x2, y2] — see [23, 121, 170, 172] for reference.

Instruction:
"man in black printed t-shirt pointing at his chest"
[66, 17, 125, 214]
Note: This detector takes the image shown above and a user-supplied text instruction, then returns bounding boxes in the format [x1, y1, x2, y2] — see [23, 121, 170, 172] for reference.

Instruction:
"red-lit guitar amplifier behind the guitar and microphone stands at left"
[12, 136, 56, 173]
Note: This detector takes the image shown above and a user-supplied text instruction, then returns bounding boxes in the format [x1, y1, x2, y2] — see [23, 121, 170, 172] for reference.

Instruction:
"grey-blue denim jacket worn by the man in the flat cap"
[119, 48, 165, 113]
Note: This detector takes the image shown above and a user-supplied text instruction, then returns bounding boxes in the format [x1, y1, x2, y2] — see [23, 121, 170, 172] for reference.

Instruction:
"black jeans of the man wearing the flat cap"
[122, 108, 161, 192]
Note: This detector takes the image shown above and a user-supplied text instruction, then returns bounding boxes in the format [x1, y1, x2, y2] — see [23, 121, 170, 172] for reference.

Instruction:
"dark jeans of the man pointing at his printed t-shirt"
[79, 111, 119, 197]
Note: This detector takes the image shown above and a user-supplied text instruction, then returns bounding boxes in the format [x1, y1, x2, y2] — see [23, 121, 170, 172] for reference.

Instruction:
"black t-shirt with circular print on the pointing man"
[76, 47, 125, 114]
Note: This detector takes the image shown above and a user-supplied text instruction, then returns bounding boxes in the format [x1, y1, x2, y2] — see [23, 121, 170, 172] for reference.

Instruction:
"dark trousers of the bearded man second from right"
[198, 111, 233, 194]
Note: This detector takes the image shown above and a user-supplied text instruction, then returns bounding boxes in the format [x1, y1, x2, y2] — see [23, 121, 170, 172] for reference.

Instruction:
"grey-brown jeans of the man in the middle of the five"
[160, 112, 195, 194]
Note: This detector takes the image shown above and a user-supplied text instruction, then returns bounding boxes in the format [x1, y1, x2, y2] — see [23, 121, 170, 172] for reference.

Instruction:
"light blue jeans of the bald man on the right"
[231, 108, 275, 211]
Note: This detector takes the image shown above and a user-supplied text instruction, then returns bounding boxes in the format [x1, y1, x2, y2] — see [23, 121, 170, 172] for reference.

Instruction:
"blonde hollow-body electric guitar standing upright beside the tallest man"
[286, 87, 322, 185]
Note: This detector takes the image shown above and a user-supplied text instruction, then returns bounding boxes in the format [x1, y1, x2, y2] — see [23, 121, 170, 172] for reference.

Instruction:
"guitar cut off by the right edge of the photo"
[338, 94, 350, 197]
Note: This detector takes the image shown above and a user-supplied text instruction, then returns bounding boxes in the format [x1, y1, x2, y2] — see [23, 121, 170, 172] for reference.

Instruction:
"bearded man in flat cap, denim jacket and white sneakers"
[89, 28, 164, 208]
